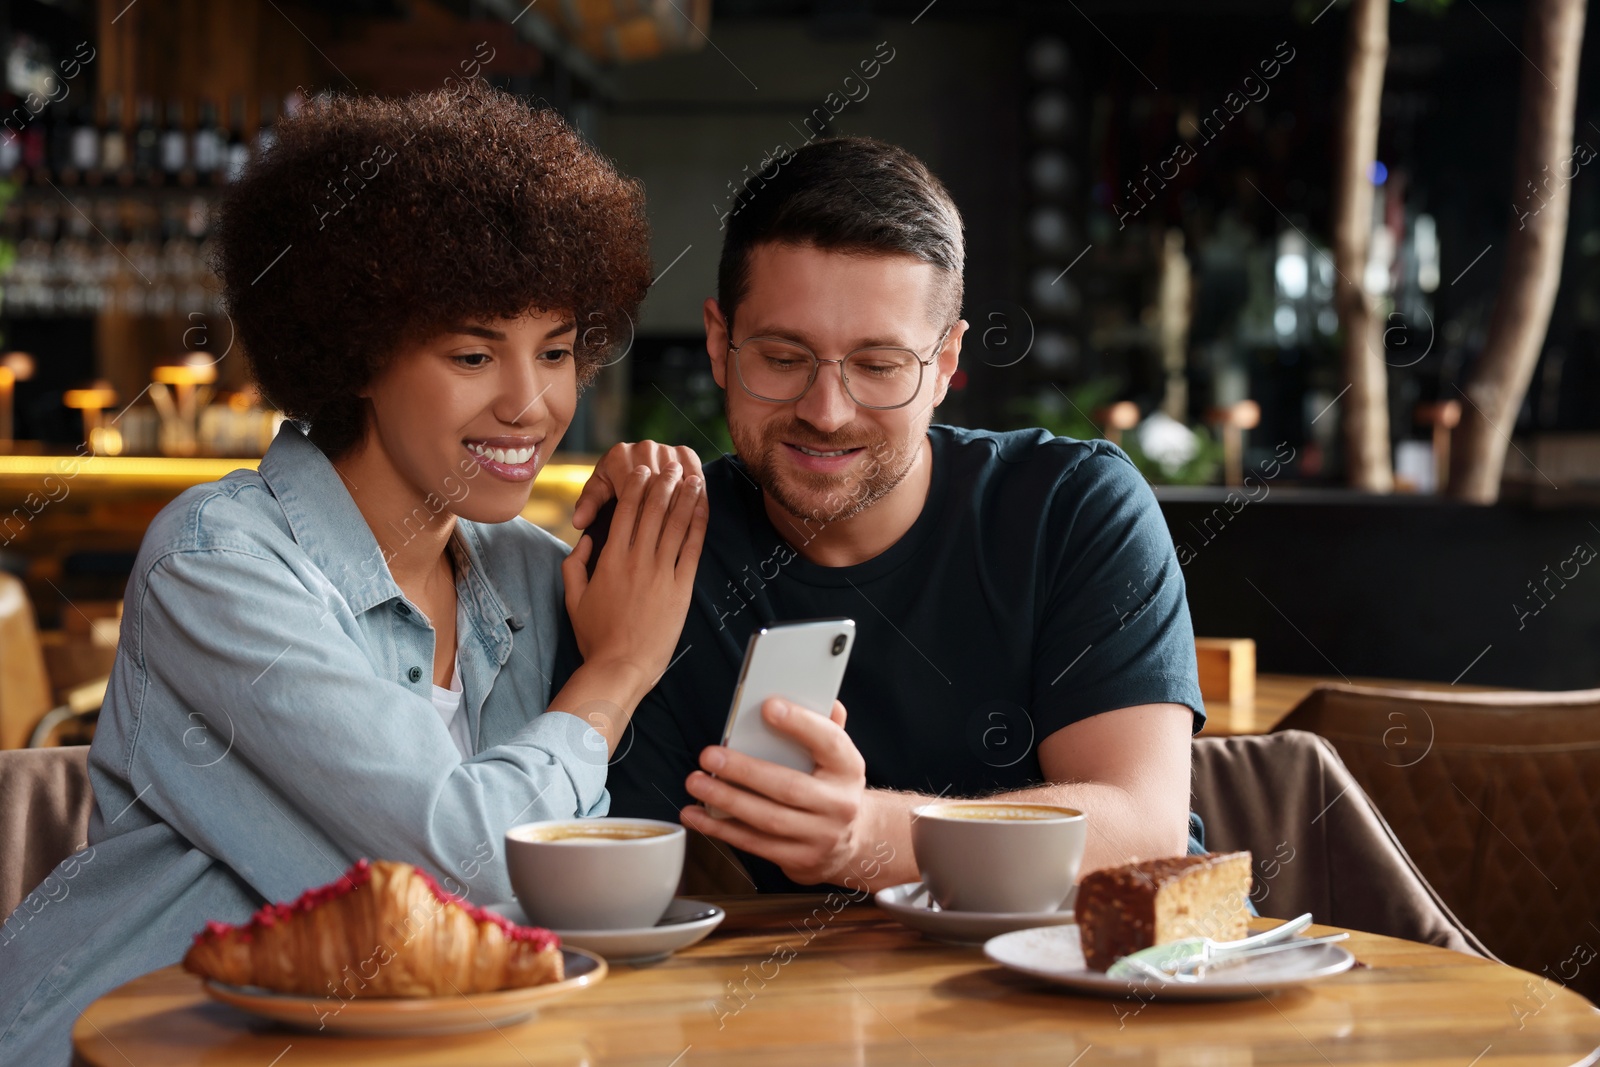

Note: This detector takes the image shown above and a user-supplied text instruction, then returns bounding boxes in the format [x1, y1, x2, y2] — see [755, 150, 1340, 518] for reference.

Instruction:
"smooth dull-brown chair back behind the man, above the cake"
[1192, 731, 1490, 955]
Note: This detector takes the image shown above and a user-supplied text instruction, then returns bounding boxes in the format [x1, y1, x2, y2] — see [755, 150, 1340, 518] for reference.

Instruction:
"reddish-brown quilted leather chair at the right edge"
[1278, 685, 1600, 1000]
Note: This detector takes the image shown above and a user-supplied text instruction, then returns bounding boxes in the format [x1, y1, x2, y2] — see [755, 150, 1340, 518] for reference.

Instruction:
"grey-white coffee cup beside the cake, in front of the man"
[910, 800, 1088, 913]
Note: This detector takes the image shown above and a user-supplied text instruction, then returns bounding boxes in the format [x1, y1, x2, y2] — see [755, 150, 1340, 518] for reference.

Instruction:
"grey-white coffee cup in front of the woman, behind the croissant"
[506, 819, 685, 931]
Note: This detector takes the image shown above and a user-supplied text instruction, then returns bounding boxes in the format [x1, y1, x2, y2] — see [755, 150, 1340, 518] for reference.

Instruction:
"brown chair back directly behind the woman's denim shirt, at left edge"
[0, 745, 94, 920]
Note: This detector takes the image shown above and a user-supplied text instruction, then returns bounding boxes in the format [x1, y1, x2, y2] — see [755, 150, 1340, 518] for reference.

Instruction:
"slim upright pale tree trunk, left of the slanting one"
[1333, 0, 1394, 493]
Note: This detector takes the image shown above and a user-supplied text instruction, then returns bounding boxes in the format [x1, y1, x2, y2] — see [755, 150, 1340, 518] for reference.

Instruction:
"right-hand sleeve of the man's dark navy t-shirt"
[1034, 445, 1205, 739]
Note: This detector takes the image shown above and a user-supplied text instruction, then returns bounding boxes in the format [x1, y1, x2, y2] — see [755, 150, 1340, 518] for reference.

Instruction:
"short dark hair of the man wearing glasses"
[717, 138, 966, 323]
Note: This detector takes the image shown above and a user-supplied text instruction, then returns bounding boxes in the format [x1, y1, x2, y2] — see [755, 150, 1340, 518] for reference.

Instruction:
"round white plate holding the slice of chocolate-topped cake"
[984, 925, 1355, 1001]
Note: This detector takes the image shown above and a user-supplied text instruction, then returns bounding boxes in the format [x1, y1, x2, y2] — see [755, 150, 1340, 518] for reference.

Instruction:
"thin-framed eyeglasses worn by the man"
[728, 323, 955, 411]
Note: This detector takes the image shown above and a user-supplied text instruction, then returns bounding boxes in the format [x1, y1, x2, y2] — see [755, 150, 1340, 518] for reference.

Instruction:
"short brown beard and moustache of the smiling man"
[728, 419, 917, 523]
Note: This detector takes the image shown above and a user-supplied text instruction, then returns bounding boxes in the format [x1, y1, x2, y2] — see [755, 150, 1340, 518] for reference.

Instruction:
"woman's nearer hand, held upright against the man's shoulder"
[562, 462, 710, 710]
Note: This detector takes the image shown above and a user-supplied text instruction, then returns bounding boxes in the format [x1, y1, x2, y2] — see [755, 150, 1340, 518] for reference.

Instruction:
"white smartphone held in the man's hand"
[712, 619, 856, 816]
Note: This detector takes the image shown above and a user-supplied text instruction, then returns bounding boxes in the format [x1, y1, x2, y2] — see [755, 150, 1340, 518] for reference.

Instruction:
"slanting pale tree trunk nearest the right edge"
[1450, 0, 1594, 504]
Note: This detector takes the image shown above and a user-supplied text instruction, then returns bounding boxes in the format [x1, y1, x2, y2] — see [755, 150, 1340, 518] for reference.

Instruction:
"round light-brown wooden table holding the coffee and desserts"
[72, 896, 1600, 1067]
